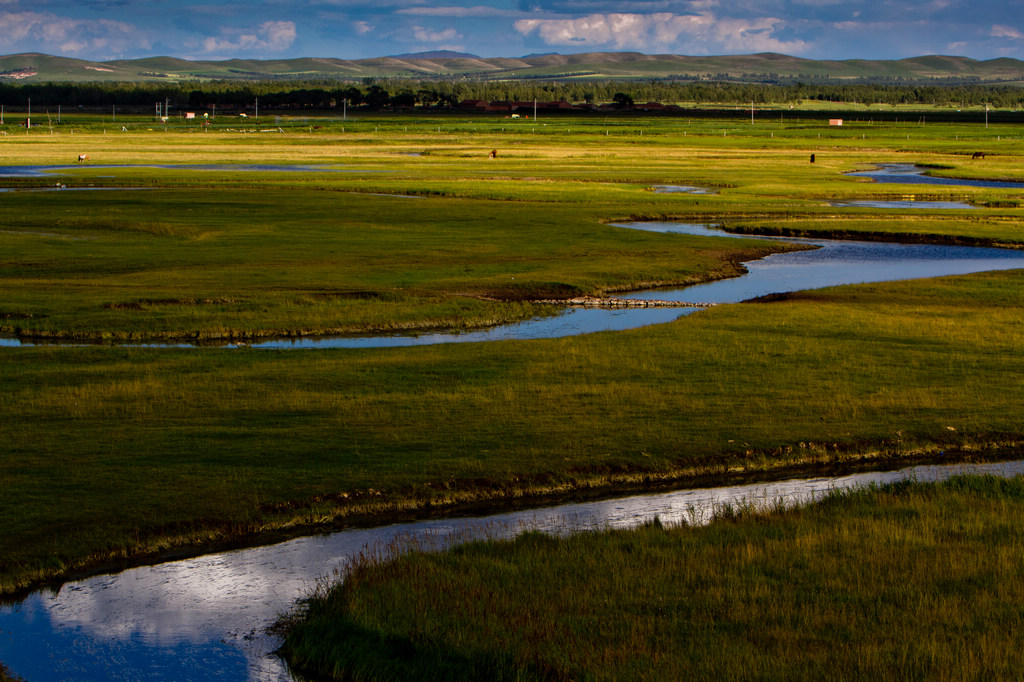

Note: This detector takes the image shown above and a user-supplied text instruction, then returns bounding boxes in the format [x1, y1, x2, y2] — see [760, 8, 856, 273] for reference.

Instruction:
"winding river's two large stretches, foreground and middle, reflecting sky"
[0, 163, 1024, 682]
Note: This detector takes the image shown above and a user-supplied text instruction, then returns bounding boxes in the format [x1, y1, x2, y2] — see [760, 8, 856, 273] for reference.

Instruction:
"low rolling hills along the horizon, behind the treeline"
[0, 51, 1024, 85]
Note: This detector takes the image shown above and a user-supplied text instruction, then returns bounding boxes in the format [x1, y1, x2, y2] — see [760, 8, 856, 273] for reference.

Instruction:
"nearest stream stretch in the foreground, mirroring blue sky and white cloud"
[0, 462, 1024, 682]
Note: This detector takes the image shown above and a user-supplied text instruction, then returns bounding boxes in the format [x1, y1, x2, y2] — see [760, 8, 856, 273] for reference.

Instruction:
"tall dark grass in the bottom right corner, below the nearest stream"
[283, 477, 1024, 680]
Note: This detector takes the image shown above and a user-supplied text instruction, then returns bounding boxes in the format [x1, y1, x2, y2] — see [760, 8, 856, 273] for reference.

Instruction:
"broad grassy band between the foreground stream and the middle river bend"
[0, 272, 1024, 589]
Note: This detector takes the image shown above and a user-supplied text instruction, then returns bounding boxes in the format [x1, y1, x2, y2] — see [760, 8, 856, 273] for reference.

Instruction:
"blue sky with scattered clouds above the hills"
[0, 0, 1024, 60]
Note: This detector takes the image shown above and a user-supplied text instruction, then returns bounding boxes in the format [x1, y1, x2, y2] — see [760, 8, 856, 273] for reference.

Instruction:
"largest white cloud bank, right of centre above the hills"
[514, 12, 807, 54]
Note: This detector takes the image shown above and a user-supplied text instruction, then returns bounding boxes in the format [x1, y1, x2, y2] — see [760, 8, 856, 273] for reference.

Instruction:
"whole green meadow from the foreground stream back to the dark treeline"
[0, 109, 1024, 592]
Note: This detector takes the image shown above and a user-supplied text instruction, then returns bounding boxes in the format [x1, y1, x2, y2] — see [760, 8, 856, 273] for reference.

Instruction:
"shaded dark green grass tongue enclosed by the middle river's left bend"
[0, 185, 777, 340]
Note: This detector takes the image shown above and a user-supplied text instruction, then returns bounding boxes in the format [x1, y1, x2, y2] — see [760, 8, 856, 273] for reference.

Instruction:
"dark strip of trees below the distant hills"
[0, 79, 1024, 111]
